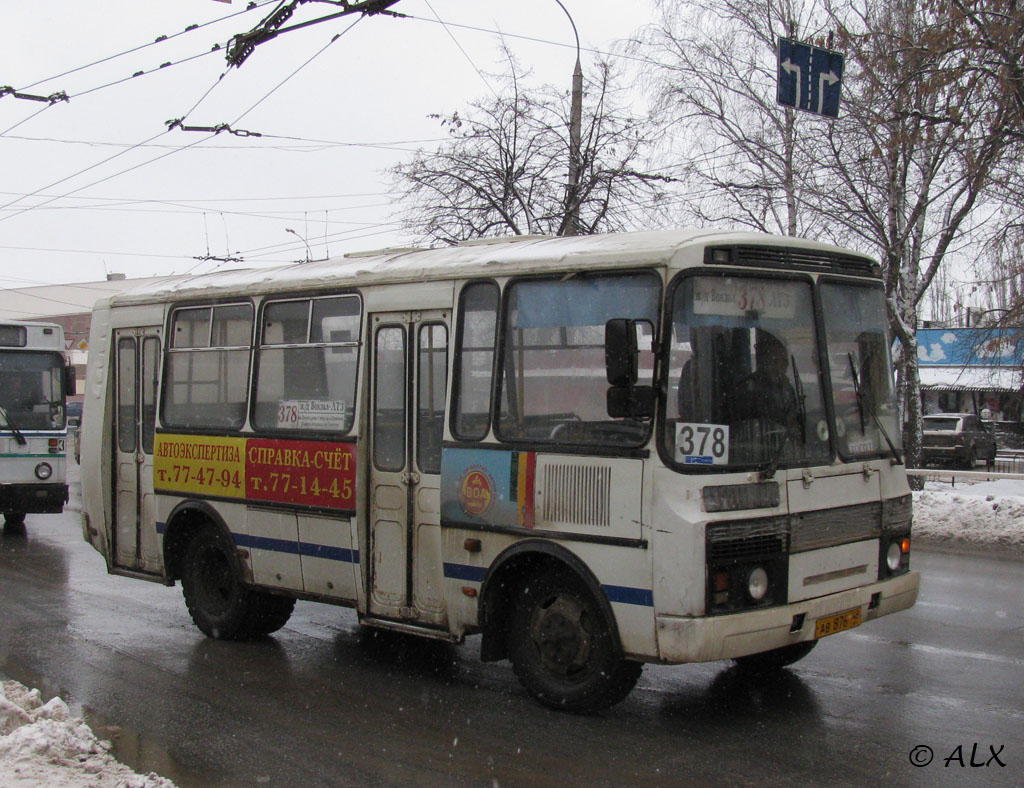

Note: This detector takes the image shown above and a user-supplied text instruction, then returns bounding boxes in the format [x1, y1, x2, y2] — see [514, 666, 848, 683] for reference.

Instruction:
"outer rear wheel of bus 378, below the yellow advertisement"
[181, 526, 258, 641]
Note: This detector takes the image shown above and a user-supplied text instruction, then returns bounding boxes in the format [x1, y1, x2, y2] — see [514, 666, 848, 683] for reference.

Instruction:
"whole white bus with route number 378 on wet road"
[82, 231, 919, 710]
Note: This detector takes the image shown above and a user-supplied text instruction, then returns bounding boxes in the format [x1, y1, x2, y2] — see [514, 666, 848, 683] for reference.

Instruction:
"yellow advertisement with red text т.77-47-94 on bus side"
[153, 434, 246, 498]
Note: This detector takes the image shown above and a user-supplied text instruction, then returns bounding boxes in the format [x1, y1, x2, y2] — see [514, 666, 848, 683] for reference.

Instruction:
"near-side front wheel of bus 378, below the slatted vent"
[509, 570, 643, 712]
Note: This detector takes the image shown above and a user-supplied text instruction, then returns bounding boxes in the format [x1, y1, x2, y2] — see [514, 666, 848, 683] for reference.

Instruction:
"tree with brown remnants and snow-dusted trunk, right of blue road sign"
[813, 0, 1015, 461]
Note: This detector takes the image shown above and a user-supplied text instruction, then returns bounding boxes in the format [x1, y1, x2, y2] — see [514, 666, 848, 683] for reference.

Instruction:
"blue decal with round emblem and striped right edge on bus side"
[441, 448, 537, 528]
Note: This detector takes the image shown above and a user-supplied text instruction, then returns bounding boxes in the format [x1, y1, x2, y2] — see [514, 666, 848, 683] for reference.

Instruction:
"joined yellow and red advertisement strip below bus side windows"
[153, 433, 355, 510]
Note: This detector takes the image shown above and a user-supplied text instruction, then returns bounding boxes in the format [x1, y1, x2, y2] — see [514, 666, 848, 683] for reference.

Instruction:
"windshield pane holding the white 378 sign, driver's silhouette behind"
[662, 275, 830, 470]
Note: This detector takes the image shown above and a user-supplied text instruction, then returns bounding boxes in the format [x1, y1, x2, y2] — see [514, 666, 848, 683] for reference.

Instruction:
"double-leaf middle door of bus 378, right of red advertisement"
[368, 310, 449, 626]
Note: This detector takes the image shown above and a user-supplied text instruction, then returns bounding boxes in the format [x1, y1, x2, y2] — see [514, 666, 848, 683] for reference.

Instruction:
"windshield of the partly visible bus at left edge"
[0, 350, 65, 430]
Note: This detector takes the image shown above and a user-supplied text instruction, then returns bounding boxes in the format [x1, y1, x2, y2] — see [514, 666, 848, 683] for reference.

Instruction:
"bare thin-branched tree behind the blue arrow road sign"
[633, 0, 825, 235]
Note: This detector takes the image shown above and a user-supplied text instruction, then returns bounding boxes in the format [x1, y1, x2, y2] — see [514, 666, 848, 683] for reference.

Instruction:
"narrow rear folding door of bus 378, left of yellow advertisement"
[114, 326, 162, 573]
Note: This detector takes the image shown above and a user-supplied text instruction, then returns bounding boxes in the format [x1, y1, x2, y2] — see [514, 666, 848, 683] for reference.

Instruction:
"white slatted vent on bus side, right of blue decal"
[541, 464, 611, 527]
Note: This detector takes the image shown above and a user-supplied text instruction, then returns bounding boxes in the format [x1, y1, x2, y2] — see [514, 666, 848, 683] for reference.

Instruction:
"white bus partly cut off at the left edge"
[0, 320, 75, 528]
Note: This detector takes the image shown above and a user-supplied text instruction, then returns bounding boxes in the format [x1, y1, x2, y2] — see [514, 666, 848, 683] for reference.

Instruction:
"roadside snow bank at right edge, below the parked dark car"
[913, 479, 1024, 554]
